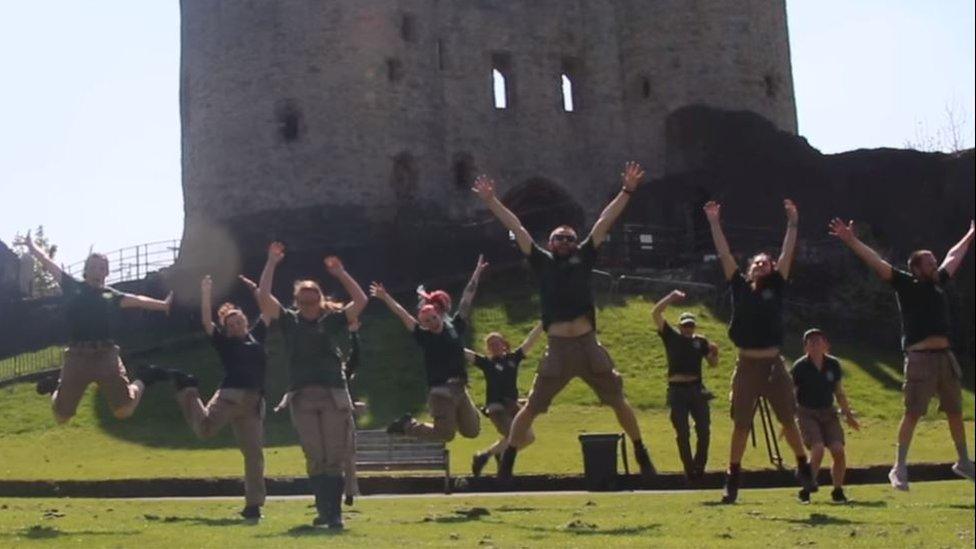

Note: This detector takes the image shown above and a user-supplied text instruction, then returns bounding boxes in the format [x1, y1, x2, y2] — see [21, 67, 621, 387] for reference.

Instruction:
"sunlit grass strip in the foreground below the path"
[0, 481, 974, 548]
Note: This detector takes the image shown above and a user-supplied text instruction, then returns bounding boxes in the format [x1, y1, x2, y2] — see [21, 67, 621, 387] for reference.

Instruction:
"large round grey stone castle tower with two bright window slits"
[180, 0, 796, 274]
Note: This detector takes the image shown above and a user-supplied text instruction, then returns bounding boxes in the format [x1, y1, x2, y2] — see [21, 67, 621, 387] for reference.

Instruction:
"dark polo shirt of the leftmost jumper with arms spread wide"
[60, 273, 126, 343]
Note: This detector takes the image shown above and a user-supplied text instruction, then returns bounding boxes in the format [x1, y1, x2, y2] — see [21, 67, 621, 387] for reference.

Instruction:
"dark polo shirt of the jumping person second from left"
[210, 318, 268, 391]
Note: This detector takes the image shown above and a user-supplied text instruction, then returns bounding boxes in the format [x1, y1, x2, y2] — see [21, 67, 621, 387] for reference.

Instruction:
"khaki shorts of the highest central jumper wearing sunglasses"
[526, 332, 624, 414]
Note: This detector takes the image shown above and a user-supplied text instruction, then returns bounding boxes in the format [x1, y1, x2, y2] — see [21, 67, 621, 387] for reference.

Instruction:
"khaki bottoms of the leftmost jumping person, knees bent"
[53, 345, 135, 417]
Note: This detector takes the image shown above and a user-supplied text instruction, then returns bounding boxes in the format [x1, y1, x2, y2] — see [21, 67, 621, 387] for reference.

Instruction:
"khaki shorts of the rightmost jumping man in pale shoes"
[902, 349, 962, 415]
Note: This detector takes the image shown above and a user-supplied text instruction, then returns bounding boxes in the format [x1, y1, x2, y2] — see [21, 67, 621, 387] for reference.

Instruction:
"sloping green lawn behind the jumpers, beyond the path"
[0, 280, 974, 479]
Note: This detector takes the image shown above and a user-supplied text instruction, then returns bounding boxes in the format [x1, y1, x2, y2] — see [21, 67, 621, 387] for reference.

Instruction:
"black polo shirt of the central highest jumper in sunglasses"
[529, 238, 597, 329]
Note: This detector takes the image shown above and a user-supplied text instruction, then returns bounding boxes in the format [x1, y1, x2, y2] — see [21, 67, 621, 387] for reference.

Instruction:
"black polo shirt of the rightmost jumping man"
[890, 269, 950, 348]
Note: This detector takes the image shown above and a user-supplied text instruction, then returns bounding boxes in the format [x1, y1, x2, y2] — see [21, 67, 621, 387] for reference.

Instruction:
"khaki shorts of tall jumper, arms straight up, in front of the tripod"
[731, 355, 796, 428]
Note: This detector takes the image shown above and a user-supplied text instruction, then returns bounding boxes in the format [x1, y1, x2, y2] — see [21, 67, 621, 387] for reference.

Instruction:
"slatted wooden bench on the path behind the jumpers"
[356, 429, 451, 494]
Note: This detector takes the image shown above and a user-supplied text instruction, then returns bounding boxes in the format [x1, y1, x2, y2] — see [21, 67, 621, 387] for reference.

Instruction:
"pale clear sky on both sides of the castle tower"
[0, 0, 976, 263]
